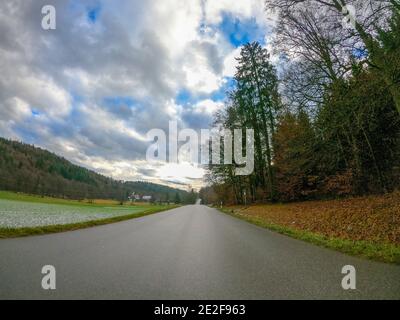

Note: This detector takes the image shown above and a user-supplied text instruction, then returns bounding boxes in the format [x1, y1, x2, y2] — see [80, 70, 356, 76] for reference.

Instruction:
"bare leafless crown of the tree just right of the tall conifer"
[274, 8, 351, 108]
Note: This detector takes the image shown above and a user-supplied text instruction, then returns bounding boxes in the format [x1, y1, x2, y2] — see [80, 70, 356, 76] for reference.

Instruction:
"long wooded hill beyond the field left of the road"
[0, 138, 194, 202]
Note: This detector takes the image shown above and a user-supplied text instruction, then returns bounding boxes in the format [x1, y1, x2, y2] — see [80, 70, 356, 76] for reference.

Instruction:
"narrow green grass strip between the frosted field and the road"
[0, 206, 179, 239]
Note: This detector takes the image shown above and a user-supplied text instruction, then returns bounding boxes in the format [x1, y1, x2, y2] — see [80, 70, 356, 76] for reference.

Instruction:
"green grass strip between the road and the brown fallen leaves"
[219, 208, 400, 264]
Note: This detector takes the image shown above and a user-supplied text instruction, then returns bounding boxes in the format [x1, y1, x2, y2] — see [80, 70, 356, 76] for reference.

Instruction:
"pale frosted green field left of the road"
[0, 199, 144, 228]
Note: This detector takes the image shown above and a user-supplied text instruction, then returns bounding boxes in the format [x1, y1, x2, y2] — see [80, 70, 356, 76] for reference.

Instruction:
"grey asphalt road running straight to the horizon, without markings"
[0, 205, 400, 299]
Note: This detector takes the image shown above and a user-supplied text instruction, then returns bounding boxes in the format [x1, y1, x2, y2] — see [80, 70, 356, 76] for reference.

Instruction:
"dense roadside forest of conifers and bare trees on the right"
[200, 0, 400, 204]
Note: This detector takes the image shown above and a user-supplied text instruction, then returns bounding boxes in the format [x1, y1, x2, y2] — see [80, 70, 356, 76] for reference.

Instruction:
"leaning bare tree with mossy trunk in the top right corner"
[266, 0, 400, 114]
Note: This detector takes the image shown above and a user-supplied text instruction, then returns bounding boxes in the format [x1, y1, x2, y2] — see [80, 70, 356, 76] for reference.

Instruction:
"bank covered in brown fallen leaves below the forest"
[231, 192, 400, 245]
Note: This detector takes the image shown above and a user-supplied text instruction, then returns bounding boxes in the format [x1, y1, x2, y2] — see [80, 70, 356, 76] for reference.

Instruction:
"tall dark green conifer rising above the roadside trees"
[233, 42, 281, 200]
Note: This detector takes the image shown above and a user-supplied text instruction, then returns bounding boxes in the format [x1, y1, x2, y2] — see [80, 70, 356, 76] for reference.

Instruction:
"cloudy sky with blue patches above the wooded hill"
[0, 0, 271, 188]
